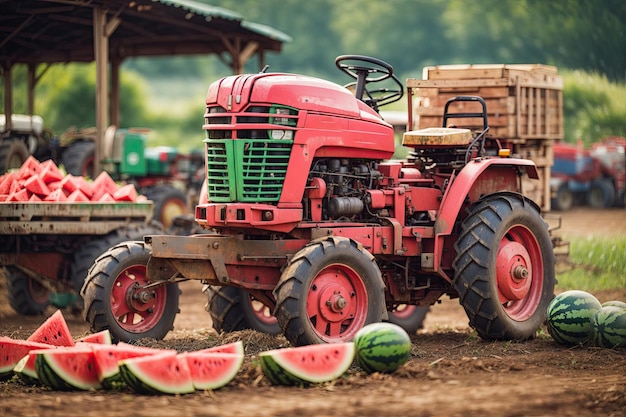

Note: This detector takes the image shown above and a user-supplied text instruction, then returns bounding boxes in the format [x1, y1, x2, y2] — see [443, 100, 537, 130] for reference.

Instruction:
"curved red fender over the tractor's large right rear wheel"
[434, 158, 539, 269]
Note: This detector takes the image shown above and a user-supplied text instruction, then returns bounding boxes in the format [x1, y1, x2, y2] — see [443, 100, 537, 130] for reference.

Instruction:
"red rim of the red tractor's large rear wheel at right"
[496, 225, 544, 321]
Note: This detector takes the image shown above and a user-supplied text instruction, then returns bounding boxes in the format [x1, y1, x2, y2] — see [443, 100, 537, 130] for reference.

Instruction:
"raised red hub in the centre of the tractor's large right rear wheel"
[496, 241, 532, 302]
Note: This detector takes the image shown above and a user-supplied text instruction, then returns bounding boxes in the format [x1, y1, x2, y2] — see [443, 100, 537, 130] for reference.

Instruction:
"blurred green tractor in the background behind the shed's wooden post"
[58, 126, 204, 229]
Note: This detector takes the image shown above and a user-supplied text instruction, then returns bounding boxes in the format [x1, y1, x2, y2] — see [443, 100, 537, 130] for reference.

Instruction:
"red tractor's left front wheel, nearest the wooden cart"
[81, 242, 180, 342]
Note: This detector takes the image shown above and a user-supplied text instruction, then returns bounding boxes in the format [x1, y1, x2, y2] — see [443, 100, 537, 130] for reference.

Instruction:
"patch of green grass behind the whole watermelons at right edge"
[557, 237, 626, 292]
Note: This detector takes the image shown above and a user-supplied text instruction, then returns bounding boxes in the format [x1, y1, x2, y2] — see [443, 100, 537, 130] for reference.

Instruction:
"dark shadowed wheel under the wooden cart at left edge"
[4, 266, 50, 316]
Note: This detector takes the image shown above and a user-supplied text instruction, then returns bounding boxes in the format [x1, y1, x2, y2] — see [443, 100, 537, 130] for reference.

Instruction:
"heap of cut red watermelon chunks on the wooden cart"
[0, 156, 141, 203]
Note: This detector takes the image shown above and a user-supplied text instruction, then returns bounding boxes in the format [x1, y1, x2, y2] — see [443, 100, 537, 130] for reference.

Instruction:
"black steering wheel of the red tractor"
[335, 55, 404, 111]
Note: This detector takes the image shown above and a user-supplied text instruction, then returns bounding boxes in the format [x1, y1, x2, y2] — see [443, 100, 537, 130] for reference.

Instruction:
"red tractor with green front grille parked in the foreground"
[82, 55, 555, 346]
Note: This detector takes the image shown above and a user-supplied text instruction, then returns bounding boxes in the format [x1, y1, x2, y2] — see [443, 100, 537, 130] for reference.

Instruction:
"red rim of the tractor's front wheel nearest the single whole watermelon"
[306, 264, 368, 343]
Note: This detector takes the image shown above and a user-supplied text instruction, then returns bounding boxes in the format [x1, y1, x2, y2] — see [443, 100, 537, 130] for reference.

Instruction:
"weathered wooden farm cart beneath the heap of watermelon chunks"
[0, 202, 161, 315]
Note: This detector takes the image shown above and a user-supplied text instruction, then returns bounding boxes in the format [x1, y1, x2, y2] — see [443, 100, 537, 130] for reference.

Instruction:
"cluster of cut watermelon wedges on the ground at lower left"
[0, 310, 244, 394]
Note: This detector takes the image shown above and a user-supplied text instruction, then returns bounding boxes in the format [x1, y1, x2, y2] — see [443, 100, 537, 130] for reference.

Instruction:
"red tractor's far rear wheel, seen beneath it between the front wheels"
[205, 286, 280, 335]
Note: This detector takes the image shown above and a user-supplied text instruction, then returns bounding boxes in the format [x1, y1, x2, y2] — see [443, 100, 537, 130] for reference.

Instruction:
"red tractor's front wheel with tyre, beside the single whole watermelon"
[274, 237, 385, 346]
